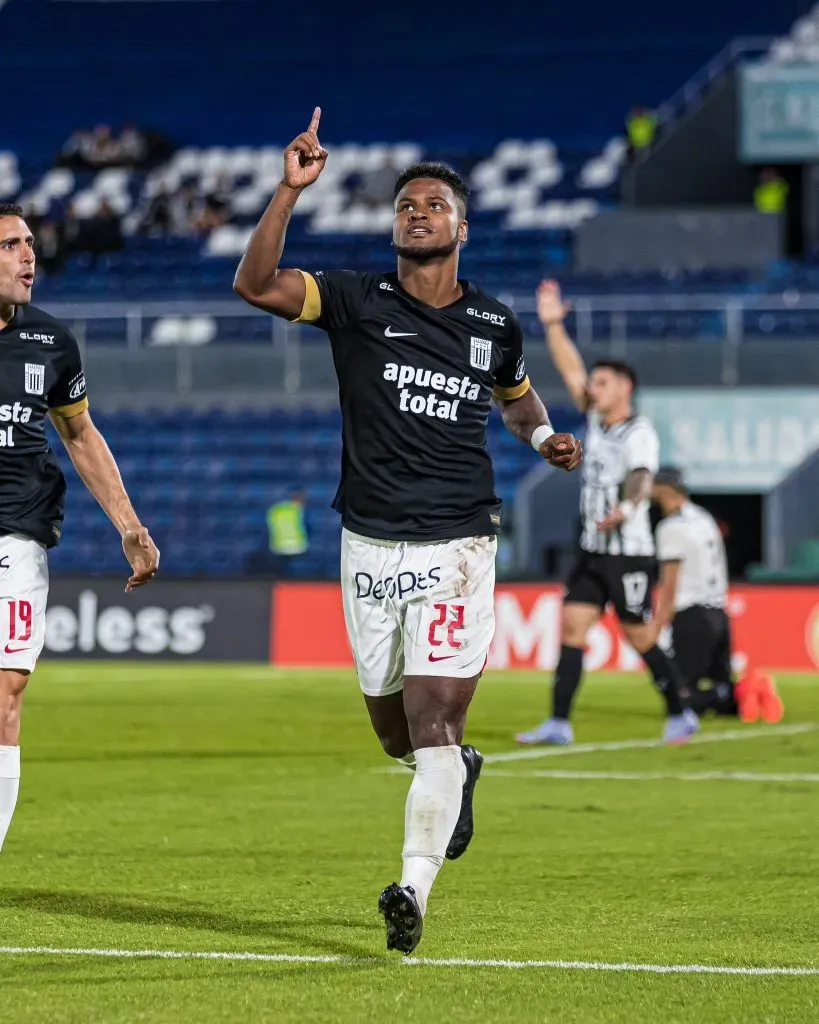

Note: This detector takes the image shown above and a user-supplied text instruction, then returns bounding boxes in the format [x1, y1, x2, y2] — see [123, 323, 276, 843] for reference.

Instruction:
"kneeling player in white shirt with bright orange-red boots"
[652, 466, 784, 722]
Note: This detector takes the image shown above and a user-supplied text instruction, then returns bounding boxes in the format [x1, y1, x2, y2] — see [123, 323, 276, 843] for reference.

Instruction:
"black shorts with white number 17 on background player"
[563, 551, 657, 624]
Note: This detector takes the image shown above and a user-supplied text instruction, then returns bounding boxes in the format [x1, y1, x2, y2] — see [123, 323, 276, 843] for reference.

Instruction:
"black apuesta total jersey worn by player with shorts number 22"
[300, 271, 529, 541]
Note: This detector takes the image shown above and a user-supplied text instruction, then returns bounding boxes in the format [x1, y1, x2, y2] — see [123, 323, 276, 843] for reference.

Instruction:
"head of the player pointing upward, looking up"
[392, 178, 467, 260]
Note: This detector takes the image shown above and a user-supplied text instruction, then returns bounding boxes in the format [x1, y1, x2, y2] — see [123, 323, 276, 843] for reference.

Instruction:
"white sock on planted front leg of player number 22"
[401, 745, 466, 914]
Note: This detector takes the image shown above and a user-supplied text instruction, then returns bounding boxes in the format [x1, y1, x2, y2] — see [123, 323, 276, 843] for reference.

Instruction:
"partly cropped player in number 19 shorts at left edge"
[0, 204, 160, 848]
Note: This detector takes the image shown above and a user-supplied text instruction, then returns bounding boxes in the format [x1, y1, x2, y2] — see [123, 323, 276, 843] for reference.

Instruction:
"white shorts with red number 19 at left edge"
[0, 534, 48, 672]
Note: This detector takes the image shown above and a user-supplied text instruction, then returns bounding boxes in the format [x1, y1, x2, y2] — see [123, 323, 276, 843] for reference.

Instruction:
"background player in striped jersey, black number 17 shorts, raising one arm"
[517, 281, 698, 743]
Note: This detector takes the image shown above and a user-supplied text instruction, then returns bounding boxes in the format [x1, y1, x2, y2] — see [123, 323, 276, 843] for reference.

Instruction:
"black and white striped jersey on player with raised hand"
[580, 412, 659, 555]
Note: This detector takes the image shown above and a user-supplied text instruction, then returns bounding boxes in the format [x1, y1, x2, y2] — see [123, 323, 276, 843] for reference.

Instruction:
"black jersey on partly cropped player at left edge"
[0, 306, 88, 548]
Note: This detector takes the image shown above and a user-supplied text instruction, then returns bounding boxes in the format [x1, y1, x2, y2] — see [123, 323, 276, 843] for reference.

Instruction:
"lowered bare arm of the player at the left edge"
[50, 410, 160, 591]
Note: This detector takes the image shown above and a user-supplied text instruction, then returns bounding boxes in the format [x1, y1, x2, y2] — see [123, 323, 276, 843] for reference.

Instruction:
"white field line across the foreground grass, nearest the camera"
[0, 946, 819, 977]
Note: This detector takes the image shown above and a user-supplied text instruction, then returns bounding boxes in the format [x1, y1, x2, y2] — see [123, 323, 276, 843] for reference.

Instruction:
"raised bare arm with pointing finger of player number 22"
[233, 106, 328, 321]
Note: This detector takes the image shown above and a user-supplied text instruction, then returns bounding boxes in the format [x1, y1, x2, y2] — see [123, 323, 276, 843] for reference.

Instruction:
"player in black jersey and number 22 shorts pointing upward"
[234, 109, 581, 952]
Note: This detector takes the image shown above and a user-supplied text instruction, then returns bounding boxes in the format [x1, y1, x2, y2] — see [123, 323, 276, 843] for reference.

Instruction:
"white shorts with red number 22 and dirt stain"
[341, 529, 498, 696]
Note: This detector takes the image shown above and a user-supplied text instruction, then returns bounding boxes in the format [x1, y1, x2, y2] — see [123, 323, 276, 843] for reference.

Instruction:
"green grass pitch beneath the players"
[0, 662, 819, 1024]
